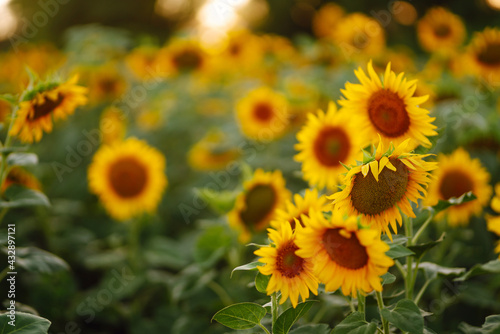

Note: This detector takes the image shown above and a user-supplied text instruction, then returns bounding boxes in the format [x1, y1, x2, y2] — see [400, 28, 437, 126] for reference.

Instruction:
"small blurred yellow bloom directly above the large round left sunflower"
[99, 106, 127, 145]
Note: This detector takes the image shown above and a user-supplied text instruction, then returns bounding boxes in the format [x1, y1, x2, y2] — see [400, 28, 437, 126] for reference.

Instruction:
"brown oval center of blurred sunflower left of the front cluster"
[240, 184, 276, 227]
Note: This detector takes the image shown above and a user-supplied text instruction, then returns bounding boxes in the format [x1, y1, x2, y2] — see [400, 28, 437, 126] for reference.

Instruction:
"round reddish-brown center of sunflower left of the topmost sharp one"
[314, 127, 350, 166]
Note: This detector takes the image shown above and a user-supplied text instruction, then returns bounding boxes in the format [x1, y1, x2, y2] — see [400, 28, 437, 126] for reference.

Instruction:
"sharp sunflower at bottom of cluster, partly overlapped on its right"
[254, 222, 318, 308]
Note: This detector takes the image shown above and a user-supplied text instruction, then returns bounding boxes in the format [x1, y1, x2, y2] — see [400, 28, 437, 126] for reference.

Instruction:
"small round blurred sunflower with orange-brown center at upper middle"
[236, 87, 289, 141]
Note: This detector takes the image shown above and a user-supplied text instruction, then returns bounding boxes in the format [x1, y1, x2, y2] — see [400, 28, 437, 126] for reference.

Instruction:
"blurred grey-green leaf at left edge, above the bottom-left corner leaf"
[11, 247, 69, 274]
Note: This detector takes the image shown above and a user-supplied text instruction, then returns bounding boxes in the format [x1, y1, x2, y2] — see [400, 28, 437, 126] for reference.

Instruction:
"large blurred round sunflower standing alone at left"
[88, 138, 167, 220]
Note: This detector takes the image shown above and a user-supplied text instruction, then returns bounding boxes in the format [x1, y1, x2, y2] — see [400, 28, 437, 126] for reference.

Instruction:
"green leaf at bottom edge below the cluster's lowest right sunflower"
[381, 299, 424, 334]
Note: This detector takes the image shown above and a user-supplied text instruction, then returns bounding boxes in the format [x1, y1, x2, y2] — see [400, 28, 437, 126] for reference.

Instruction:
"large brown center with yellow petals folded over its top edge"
[351, 159, 409, 215]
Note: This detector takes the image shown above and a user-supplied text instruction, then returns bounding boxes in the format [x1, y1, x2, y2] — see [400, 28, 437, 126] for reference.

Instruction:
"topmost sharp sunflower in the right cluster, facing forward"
[339, 61, 437, 148]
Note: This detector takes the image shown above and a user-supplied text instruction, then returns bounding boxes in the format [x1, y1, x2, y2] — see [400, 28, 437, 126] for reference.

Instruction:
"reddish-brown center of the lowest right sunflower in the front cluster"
[323, 228, 368, 269]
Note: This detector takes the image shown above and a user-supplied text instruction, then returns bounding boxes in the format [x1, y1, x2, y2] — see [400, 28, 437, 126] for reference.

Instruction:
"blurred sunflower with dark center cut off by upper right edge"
[466, 28, 500, 83]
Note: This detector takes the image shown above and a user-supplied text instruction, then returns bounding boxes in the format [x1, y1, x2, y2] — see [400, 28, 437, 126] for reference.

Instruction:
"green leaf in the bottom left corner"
[0, 312, 50, 334]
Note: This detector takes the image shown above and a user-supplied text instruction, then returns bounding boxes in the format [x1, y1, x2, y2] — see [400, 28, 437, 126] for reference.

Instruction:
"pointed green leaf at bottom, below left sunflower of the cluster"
[212, 303, 266, 329]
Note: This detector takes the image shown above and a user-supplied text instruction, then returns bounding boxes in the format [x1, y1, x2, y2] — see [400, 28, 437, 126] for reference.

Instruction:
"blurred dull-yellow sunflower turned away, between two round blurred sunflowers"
[188, 131, 240, 171]
